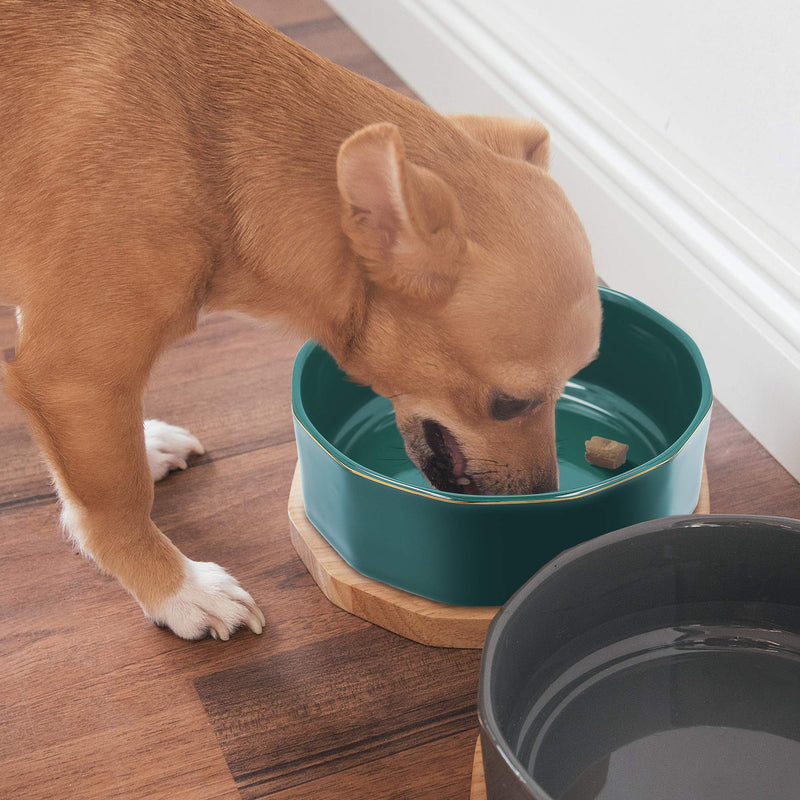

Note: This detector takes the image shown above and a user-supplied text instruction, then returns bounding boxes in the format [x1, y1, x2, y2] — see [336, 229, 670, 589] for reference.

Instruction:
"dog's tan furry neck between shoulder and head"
[199, 4, 464, 356]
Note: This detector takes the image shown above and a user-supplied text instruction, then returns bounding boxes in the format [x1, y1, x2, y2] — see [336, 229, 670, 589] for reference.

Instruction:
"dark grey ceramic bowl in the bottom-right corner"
[479, 516, 800, 800]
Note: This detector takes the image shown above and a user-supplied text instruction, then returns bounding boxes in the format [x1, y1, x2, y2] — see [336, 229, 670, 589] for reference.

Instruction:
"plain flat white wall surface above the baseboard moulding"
[506, 0, 800, 253]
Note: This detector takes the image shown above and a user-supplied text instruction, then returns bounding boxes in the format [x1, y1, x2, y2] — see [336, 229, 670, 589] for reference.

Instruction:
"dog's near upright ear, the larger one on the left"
[337, 123, 464, 302]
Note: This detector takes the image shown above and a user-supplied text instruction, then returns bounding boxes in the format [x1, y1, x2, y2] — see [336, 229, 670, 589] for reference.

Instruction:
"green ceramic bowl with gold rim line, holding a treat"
[292, 289, 712, 605]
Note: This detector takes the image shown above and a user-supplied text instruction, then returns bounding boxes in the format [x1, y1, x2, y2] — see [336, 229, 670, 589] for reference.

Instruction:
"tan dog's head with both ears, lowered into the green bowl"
[337, 117, 601, 494]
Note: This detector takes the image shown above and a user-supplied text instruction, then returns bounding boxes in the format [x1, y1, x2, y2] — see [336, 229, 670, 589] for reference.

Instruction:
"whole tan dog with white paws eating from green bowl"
[0, 0, 600, 639]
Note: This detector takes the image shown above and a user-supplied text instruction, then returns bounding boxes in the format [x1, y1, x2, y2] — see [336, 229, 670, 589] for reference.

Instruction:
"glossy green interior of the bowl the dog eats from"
[295, 289, 711, 494]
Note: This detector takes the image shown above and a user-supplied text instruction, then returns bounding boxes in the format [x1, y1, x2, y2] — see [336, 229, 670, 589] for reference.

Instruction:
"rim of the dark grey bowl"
[478, 514, 800, 800]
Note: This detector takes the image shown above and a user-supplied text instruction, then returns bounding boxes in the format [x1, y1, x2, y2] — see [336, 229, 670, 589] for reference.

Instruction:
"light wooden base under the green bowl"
[289, 464, 710, 650]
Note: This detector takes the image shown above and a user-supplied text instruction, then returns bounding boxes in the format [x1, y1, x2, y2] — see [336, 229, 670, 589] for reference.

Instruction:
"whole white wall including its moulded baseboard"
[328, 0, 800, 479]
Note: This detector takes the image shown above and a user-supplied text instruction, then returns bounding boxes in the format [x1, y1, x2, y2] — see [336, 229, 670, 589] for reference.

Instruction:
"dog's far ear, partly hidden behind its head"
[450, 114, 550, 170]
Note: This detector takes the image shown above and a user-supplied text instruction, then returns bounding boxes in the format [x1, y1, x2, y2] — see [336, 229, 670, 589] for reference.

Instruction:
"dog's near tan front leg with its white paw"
[6, 346, 264, 639]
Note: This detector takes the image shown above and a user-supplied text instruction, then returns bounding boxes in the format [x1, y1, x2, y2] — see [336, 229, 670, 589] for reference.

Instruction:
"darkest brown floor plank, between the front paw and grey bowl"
[195, 626, 480, 798]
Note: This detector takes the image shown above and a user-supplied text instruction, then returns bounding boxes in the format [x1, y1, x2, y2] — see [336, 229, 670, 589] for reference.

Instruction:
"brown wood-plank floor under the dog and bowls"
[0, 0, 800, 800]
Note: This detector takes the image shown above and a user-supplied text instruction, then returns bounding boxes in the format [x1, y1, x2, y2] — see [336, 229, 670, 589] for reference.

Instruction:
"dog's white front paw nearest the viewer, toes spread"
[145, 558, 266, 641]
